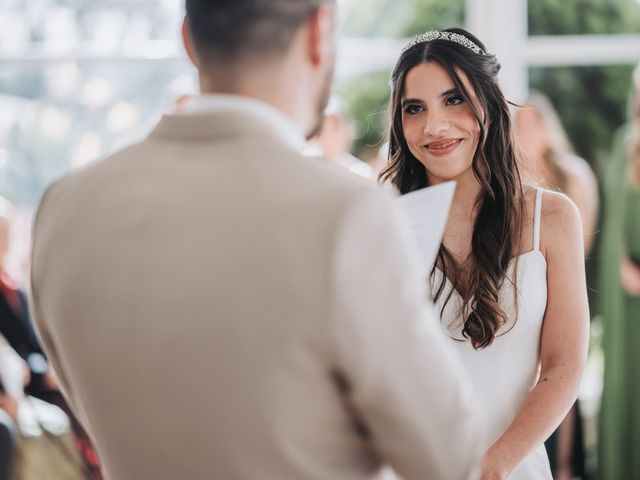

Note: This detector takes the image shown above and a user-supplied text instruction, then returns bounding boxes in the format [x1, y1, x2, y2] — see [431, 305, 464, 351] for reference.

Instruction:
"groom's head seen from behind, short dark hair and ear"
[183, 0, 335, 138]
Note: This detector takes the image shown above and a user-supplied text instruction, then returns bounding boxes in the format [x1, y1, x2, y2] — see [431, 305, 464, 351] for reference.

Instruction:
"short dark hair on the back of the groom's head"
[186, 0, 335, 64]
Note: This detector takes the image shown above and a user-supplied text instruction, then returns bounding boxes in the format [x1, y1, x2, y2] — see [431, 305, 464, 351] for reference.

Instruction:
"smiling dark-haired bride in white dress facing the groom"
[381, 29, 589, 480]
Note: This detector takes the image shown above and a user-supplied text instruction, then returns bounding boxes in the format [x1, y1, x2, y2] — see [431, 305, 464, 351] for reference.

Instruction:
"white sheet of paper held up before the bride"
[396, 181, 456, 272]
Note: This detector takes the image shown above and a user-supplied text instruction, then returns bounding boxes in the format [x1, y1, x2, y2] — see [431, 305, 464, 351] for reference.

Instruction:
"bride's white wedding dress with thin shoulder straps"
[432, 189, 552, 480]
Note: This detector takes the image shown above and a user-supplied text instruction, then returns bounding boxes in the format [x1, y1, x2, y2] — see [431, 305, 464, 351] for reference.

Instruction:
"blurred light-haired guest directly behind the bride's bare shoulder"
[514, 93, 598, 480]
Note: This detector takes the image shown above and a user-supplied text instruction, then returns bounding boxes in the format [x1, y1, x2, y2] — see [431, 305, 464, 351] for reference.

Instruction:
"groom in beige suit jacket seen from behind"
[27, 0, 481, 480]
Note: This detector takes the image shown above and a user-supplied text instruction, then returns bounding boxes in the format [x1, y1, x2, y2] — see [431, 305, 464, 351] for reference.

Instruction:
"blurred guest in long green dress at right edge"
[598, 65, 640, 480]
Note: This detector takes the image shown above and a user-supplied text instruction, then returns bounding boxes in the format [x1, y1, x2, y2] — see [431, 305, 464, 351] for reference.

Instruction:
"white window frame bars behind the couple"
[0, 0, 640, 101]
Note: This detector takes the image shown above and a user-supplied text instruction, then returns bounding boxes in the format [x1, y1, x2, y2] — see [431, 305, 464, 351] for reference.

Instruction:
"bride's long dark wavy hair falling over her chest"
[380, 28, 524, 349]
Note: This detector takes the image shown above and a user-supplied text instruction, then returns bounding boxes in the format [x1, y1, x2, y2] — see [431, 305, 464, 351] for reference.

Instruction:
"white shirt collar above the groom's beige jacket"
[183, 93, 306, 152]
